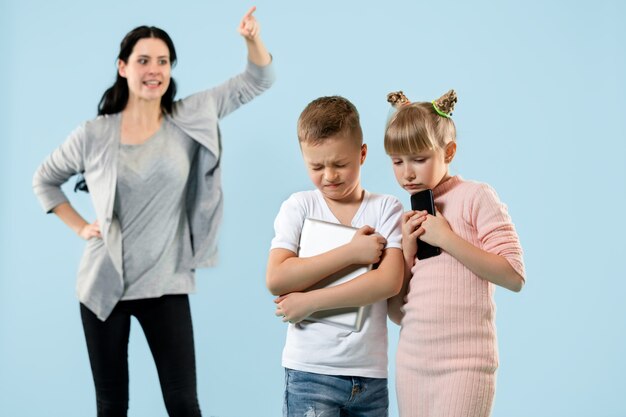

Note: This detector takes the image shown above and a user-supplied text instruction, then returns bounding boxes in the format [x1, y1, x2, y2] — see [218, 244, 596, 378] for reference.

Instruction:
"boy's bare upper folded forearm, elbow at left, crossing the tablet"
[265, 243, 355, 295]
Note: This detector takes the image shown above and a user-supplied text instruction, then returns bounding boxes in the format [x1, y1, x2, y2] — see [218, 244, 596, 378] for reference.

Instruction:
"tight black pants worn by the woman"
[80, 295, 201, 417]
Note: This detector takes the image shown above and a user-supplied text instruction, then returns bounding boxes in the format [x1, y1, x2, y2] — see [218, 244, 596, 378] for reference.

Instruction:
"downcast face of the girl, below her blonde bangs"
[390, 142, 456, 194]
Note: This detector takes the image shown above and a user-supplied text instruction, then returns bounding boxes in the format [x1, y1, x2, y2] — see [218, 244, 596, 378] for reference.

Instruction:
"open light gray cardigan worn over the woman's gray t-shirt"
[33, 62, 274, 320]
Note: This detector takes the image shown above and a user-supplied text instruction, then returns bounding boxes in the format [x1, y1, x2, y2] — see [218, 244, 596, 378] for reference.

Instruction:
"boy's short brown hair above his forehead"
[298, 96, 363, 145]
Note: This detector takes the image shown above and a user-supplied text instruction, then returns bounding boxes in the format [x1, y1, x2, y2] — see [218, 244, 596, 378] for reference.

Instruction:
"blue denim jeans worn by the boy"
[283, 368, 389, 417]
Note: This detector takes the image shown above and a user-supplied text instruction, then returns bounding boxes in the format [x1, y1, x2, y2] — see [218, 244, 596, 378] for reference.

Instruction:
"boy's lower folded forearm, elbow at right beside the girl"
[306, 248, 404, 311]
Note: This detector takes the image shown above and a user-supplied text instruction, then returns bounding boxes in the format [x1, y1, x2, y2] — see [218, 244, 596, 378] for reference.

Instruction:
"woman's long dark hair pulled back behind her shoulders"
[98, 26, 176, 116]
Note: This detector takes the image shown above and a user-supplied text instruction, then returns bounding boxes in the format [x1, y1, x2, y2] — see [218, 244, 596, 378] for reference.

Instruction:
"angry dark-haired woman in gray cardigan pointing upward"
[33, 8, 273, 417]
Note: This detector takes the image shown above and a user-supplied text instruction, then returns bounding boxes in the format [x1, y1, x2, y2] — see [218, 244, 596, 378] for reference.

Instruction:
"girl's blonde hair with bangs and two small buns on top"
[385, 90, 457, 155]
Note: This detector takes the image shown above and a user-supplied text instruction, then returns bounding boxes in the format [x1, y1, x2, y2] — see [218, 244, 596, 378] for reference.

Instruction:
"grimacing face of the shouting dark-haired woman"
[118, 38, 172, 103]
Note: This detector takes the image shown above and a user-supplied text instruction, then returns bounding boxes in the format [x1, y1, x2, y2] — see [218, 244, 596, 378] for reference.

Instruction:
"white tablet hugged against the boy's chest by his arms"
[298, 218, 372, 332]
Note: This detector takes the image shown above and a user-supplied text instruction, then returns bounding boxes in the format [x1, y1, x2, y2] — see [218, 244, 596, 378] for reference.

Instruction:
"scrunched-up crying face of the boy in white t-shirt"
[301, 136, 367, 203]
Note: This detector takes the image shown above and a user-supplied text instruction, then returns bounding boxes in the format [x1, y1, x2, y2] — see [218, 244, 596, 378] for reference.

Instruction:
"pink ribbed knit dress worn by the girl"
[396, 176, 525, 417]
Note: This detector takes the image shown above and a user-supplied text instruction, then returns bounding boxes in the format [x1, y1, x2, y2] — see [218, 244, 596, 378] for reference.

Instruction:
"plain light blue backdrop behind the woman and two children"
[0, 0, 626, 417]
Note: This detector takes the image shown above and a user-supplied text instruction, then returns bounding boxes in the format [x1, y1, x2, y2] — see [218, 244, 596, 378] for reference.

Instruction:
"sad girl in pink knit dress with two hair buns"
[385, 90, 525, 417]
